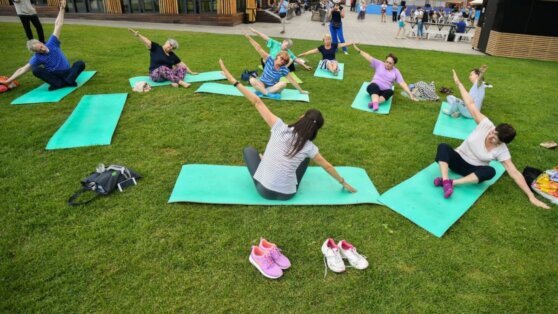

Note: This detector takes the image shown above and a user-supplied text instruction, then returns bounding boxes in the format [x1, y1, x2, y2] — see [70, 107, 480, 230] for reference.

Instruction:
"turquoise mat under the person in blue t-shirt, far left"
[12, 71, 97, 105]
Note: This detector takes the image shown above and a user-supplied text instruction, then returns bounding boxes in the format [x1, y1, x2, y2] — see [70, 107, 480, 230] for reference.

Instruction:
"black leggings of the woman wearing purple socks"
[436, 143, 496, 183]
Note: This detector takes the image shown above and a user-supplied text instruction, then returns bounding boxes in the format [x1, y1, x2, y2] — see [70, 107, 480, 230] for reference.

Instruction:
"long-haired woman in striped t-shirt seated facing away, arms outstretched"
[219, 60, 356, 200]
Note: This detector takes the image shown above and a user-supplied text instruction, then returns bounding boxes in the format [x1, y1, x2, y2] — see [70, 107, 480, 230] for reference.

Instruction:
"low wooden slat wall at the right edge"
[486, 31, 558, 61]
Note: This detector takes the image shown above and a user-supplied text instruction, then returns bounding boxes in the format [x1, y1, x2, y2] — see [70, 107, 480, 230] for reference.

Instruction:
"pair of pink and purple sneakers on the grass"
[248, 238, 291, 279]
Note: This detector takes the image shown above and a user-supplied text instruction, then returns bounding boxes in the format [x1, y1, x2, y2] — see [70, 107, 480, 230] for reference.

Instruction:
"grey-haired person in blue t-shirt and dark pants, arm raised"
[3, 0, 85, 91]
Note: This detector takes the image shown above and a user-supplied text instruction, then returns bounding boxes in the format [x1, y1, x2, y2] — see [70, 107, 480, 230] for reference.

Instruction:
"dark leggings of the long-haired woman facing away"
[244, 147, 310, 201]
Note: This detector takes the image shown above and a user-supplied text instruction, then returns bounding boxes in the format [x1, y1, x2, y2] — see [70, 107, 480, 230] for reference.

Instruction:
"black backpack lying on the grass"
[68, 164, 141, 206]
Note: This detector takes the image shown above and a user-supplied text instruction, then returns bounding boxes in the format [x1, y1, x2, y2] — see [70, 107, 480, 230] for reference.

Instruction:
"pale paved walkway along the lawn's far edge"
[0, 12, 482, 55]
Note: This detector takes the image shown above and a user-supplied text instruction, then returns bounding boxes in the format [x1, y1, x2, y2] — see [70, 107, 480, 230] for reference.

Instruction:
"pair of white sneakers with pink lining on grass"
[322, 238, 368, 275]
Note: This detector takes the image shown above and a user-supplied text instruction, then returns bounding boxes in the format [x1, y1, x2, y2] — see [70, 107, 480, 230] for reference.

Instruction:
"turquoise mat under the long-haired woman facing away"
[169, 164, 379, 205]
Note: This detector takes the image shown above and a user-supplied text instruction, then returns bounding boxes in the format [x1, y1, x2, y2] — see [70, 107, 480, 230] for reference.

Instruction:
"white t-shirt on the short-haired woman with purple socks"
[455, 118, 511, 166]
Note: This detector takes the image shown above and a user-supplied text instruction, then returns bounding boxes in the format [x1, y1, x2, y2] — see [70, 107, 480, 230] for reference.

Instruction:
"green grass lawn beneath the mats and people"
[0, 23, 558, 313]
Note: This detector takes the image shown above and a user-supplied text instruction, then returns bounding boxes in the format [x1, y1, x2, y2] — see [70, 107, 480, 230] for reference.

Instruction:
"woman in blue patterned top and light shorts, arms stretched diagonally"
[245, 34, 308, 99]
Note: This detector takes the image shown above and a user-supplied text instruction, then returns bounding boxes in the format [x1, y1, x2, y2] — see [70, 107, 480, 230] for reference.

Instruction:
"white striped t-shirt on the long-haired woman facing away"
[254, 119, 318, 194]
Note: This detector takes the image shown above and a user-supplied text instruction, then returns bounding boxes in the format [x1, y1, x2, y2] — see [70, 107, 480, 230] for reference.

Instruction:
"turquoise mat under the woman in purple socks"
[379, 161, 504, 237]
